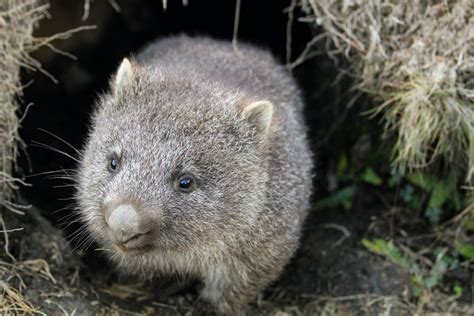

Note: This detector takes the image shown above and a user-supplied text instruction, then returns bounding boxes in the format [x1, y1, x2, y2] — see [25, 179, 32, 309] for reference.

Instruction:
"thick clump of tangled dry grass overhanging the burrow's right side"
[299, 0, 474, 183]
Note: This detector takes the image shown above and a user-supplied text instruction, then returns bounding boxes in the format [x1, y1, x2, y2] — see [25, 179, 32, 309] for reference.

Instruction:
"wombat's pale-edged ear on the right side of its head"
[240, 100, 273, 135]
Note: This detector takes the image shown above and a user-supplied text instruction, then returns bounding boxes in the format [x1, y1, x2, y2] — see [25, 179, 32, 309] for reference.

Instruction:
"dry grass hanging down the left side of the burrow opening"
[0, 0, 47, 211]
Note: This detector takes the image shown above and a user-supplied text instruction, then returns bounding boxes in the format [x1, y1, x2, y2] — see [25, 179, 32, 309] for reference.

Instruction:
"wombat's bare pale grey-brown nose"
[105, 204, 143, 243]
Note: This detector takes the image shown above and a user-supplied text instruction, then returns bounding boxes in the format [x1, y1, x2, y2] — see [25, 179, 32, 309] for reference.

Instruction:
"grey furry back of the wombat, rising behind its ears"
[137, 35, 302, 110]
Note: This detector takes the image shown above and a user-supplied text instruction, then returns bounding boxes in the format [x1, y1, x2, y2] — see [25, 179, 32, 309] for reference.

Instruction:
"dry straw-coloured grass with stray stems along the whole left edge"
[0, 0, 94, 315]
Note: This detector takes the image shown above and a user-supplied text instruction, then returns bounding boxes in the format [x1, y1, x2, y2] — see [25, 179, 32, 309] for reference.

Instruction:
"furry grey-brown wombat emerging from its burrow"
[77, 35, 312, 315]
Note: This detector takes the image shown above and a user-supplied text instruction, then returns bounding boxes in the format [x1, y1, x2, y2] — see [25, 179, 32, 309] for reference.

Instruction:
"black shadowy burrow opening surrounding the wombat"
[15, 0, 378, 306]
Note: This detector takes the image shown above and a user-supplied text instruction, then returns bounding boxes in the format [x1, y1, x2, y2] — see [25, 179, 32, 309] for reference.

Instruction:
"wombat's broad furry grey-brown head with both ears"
[77, 59, 274, 257]
